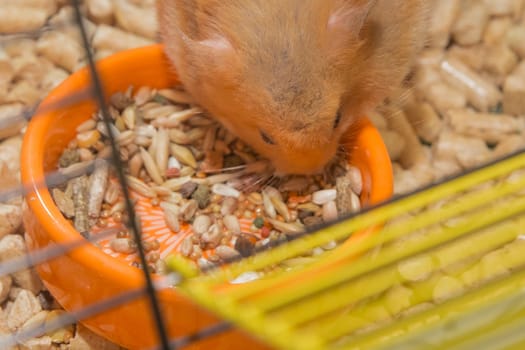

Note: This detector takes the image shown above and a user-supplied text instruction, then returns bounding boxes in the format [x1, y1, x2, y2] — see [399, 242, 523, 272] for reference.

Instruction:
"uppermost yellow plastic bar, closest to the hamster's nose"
[192, 153, 525, 284]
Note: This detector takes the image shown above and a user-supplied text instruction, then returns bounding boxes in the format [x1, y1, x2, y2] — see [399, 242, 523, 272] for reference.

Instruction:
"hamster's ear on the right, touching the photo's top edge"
[327, 0, 377, 41]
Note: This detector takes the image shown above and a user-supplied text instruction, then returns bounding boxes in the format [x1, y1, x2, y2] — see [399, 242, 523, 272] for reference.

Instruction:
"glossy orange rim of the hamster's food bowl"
[21, 44, 393, 287]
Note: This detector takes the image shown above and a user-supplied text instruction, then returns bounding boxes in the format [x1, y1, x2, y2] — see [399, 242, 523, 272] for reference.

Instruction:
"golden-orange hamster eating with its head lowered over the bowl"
[157, 0, 427, 174]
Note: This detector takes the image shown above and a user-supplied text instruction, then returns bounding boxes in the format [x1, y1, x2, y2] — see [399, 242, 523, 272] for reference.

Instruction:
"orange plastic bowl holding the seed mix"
[21, 45, 393, 349]
